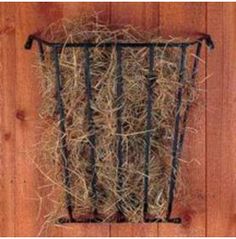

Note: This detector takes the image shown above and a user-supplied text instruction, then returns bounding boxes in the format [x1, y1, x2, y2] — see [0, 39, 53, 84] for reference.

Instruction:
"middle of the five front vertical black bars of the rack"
[116, 46, 124, 220]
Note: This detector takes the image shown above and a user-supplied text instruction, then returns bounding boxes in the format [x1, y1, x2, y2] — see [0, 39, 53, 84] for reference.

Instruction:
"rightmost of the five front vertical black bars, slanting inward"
[166, 45, 186, 220]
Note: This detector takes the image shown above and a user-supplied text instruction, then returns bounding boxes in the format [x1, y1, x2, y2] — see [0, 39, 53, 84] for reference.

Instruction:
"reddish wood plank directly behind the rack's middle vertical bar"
[111, 2, 159, 237]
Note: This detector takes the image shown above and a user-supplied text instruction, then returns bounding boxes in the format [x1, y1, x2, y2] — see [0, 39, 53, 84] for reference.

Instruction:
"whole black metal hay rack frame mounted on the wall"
[25, 34, 214, 223]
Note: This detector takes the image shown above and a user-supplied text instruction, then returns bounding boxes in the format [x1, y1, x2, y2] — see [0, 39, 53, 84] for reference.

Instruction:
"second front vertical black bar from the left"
[84, 47, 97, 214]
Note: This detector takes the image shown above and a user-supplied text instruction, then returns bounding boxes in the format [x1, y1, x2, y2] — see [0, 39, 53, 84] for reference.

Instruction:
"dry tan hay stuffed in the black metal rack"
[34, 16, 200, 222]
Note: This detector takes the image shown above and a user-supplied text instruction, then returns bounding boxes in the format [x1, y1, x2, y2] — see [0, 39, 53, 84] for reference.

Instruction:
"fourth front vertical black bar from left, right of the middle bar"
[143, 46, 155, 219]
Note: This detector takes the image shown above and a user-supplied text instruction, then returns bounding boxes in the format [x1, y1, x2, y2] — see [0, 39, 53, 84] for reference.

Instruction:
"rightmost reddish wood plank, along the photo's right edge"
[207, 3, 236, 237]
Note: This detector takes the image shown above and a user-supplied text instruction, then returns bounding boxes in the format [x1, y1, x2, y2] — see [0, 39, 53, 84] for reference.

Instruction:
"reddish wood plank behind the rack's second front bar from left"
[62, 3, 110, 237]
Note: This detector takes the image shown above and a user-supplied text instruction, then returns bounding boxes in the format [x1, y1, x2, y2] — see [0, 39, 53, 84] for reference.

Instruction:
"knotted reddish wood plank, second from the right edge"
[159, 2, 206, 236]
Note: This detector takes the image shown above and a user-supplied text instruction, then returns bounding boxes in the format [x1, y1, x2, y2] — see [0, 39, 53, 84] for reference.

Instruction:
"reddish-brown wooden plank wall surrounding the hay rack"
[0, 3, 236, 236]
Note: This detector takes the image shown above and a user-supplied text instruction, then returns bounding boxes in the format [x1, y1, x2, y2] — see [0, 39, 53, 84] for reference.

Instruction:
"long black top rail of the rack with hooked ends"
[25, 34, 214, 49]
